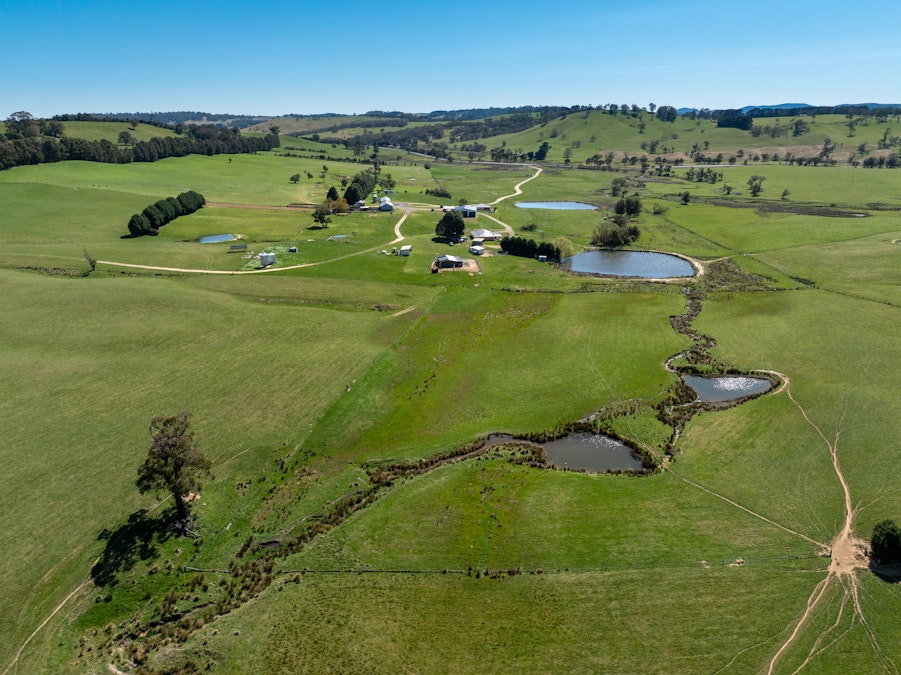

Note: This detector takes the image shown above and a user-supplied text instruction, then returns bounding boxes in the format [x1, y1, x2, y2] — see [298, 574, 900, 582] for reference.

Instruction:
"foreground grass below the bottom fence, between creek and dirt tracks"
[176, 564, 828, 673]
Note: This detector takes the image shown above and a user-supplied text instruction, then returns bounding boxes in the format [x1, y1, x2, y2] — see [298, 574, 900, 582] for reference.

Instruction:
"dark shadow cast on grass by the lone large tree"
[91, 508, 174, 586]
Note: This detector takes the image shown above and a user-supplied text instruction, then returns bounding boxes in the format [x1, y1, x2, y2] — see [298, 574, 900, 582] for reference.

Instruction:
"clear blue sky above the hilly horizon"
[0, 0, 901, 119]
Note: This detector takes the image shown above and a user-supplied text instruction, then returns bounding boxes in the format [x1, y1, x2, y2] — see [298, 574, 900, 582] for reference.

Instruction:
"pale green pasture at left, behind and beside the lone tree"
[0, 271, 414, 661]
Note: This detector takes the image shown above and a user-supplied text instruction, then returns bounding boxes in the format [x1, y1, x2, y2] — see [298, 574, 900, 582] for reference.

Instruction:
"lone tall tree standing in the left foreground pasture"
[135, 410, 210, 524]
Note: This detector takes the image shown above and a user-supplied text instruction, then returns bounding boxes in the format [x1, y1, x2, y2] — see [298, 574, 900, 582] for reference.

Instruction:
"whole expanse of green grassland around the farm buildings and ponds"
[0, 119, 901, 673]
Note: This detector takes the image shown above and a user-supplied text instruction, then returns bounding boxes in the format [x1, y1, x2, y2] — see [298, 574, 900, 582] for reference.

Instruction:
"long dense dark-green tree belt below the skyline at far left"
[0, 113, 280, 170]
